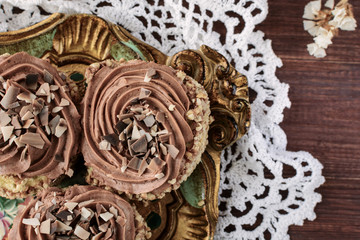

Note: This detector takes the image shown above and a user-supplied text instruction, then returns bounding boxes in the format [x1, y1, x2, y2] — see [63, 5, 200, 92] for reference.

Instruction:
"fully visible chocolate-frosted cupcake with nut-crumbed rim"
[82, 60, 209, 198]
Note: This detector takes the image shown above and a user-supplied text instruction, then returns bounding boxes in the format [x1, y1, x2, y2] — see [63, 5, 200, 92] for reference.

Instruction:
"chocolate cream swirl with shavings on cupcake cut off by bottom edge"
[9, 185, 149, 240]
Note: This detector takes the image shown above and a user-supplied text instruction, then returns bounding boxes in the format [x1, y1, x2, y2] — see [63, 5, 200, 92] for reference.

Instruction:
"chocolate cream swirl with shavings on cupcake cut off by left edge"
[0, 52, 80, 179]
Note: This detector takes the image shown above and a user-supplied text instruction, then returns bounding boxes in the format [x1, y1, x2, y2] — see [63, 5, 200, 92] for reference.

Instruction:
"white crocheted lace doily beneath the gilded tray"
[0, 0, 324, 239]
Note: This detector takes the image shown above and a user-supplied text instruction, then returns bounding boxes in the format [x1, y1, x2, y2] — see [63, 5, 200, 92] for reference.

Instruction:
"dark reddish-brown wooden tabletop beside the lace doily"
[258, 0, 360, 240]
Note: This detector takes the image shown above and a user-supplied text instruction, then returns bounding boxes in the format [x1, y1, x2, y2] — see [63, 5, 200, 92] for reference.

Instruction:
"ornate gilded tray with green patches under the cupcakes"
[0, 13, 250, 239]
